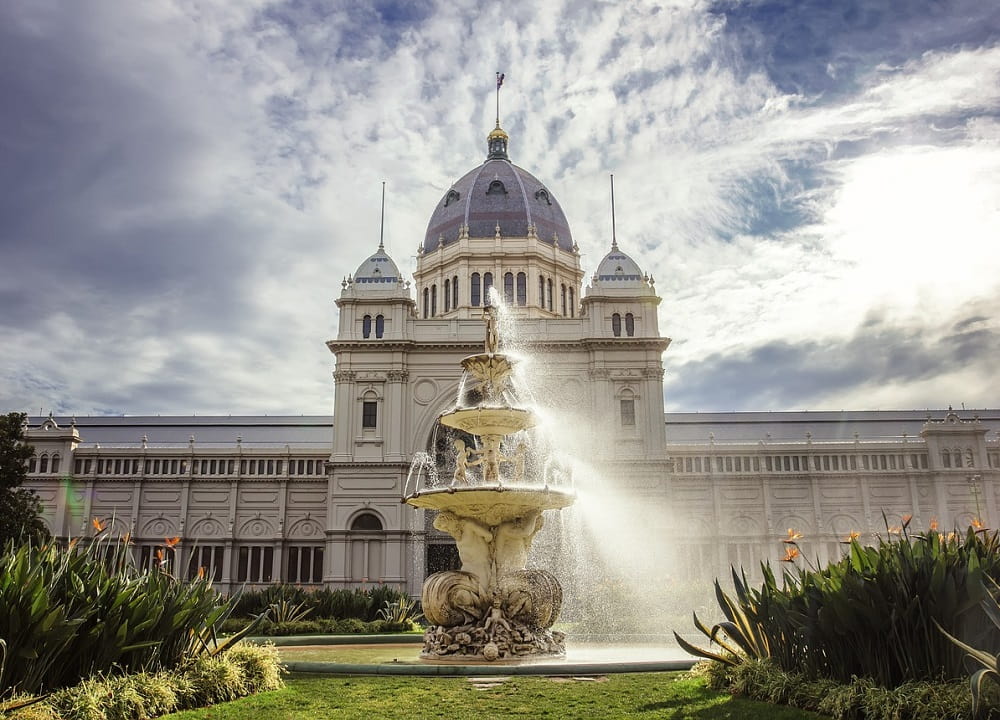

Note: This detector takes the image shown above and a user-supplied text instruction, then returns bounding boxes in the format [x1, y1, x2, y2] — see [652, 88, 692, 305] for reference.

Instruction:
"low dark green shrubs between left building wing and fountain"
[233, 584, 409, 622]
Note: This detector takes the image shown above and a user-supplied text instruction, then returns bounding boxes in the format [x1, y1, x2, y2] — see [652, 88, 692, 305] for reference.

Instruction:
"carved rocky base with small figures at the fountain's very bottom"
[420, 615, 566, 662]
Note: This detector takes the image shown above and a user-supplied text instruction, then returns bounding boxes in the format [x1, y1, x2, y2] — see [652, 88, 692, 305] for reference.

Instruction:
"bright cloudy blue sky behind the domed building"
[0, 0, 1000, 415]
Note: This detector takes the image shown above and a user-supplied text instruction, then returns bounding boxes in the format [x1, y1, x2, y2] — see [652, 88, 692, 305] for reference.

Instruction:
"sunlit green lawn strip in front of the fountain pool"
[165, 673, 822, 720]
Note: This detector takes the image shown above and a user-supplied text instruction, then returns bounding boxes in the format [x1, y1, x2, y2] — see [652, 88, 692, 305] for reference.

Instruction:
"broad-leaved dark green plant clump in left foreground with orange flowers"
[0, 536, 262, 697]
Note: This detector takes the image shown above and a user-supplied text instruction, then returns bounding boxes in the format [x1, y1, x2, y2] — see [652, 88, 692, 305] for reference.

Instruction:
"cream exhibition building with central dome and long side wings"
[19, 124, 1000, 596]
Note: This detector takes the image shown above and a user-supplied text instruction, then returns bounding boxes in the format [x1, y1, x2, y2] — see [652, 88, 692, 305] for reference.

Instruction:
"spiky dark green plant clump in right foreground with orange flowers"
[679, 528, 1000, 688]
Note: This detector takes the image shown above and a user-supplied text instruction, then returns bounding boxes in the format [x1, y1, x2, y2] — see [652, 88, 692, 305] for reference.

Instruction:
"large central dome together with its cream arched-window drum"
[413, 122, 583, 319]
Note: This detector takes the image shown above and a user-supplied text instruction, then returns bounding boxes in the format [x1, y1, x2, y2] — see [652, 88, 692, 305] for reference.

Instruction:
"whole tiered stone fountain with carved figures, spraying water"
[404, 307, 574, 662]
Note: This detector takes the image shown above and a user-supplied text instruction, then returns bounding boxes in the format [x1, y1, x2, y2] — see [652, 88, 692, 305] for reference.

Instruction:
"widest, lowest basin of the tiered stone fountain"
[405, 486, 576, 526]
